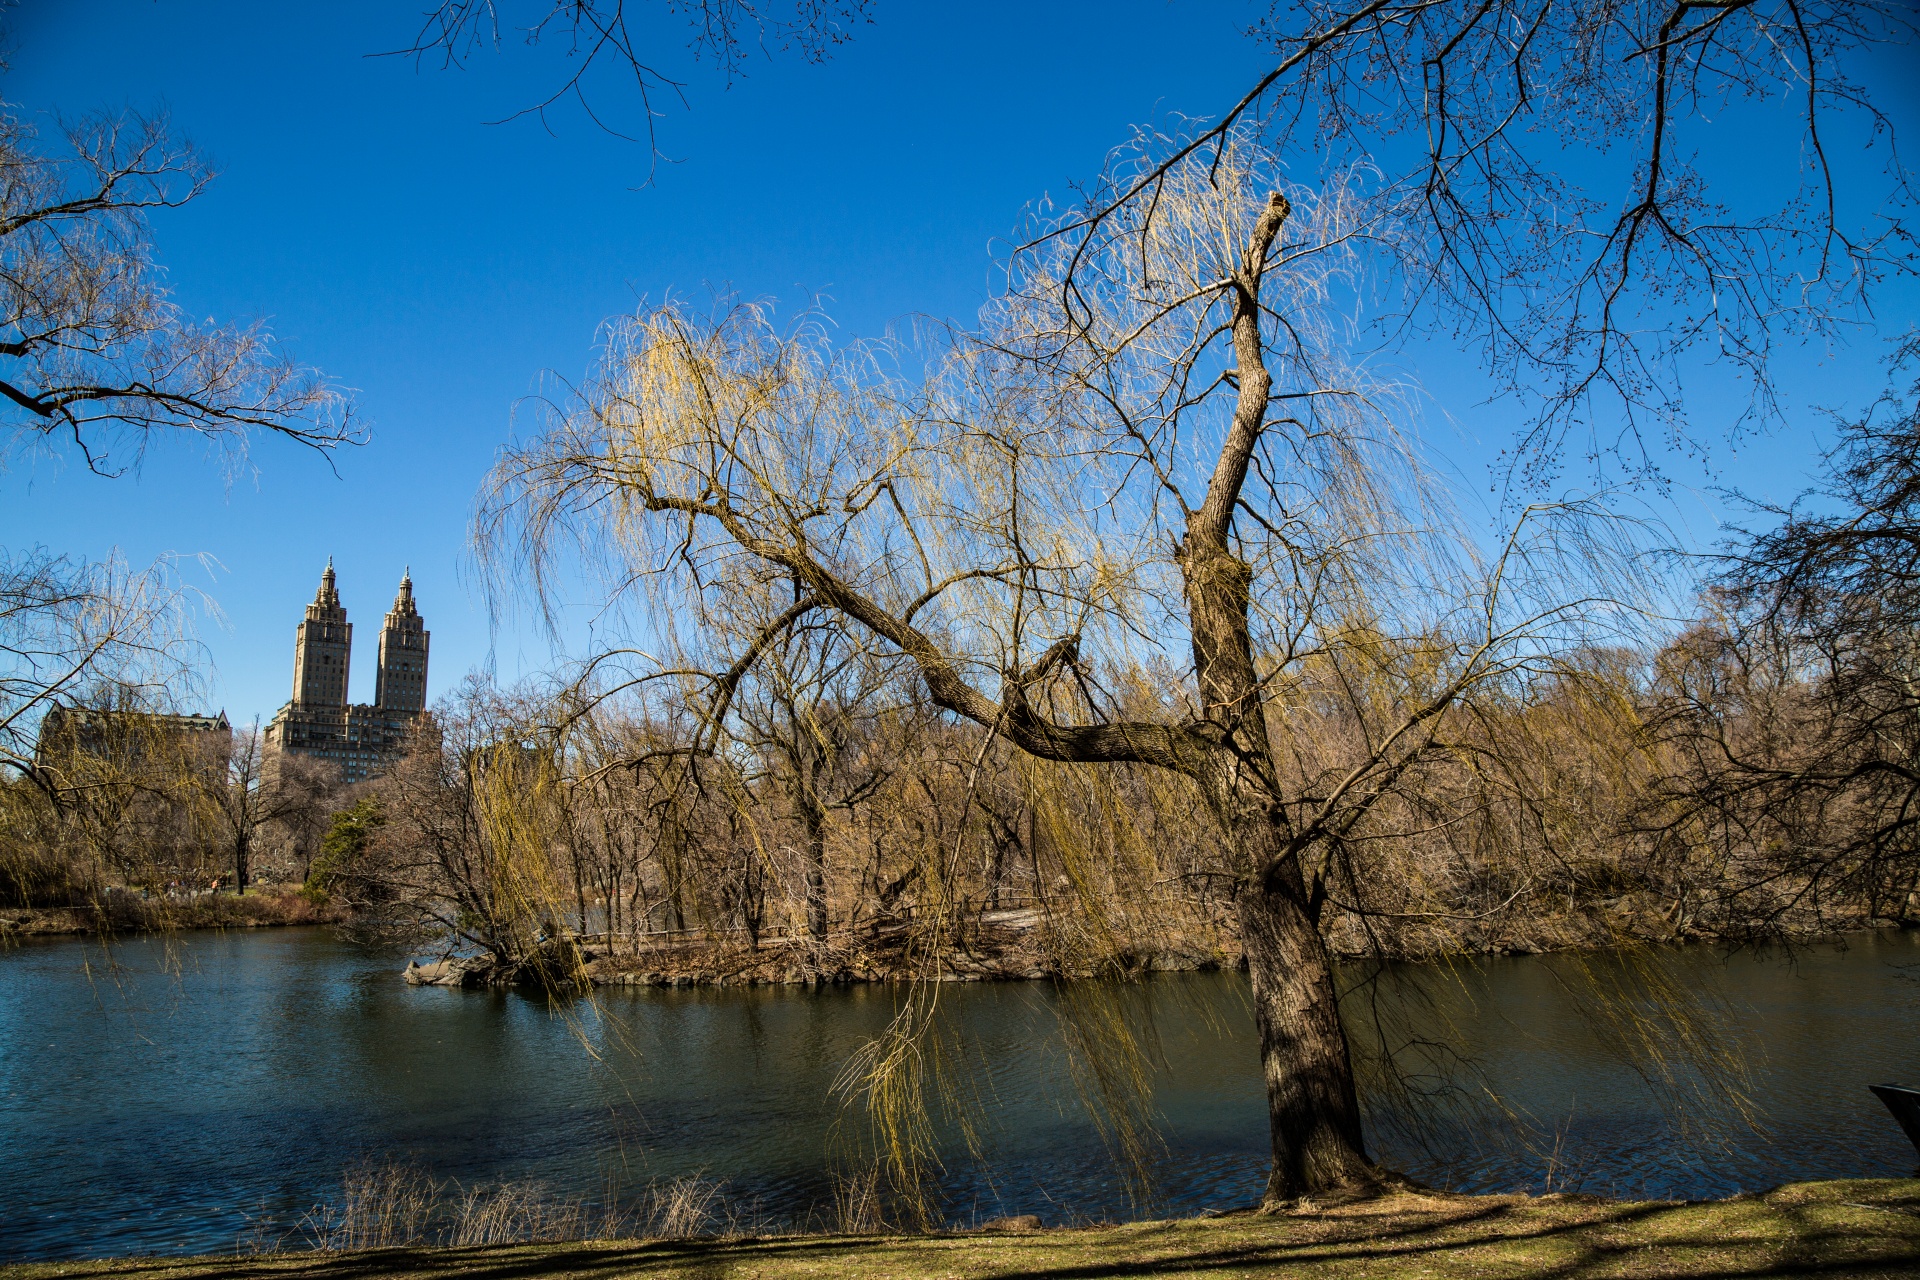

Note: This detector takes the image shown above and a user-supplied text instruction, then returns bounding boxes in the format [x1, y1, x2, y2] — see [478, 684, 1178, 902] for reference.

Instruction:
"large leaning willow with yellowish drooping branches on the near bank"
[478, 136, 1666, 1203]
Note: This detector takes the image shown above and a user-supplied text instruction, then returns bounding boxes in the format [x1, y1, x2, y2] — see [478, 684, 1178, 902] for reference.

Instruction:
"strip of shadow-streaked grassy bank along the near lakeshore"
[0, 1178, 1920, 1280]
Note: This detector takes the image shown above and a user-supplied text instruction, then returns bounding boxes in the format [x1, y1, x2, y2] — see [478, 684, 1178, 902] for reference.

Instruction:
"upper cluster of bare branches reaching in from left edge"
[0, 115, 355, 474]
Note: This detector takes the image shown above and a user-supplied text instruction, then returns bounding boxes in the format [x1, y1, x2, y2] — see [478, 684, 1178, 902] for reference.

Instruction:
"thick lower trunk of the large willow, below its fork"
[1236, 831, 1382, 1205]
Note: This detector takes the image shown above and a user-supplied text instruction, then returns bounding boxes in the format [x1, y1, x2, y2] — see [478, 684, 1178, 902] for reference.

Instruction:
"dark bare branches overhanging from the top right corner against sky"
[1064, 0, 1916, 480]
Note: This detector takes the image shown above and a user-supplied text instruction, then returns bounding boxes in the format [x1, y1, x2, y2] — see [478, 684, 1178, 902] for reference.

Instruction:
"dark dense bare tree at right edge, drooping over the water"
[1644, 334, 1920, 938]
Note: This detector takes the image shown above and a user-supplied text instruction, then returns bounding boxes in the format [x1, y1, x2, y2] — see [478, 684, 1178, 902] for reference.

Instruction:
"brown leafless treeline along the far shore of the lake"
[0, 581, 1920, 975]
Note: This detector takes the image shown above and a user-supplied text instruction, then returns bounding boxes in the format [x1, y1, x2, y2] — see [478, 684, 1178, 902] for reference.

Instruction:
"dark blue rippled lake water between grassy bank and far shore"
[0, 929, 1920, 1261]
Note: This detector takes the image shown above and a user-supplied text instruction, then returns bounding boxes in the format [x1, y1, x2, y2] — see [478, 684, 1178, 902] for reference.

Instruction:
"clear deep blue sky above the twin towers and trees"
[0, 0, 1912, 720]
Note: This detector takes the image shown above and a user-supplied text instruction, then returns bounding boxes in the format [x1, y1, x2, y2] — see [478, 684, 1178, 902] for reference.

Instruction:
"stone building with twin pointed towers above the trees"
[267, 558, 432, 783]
